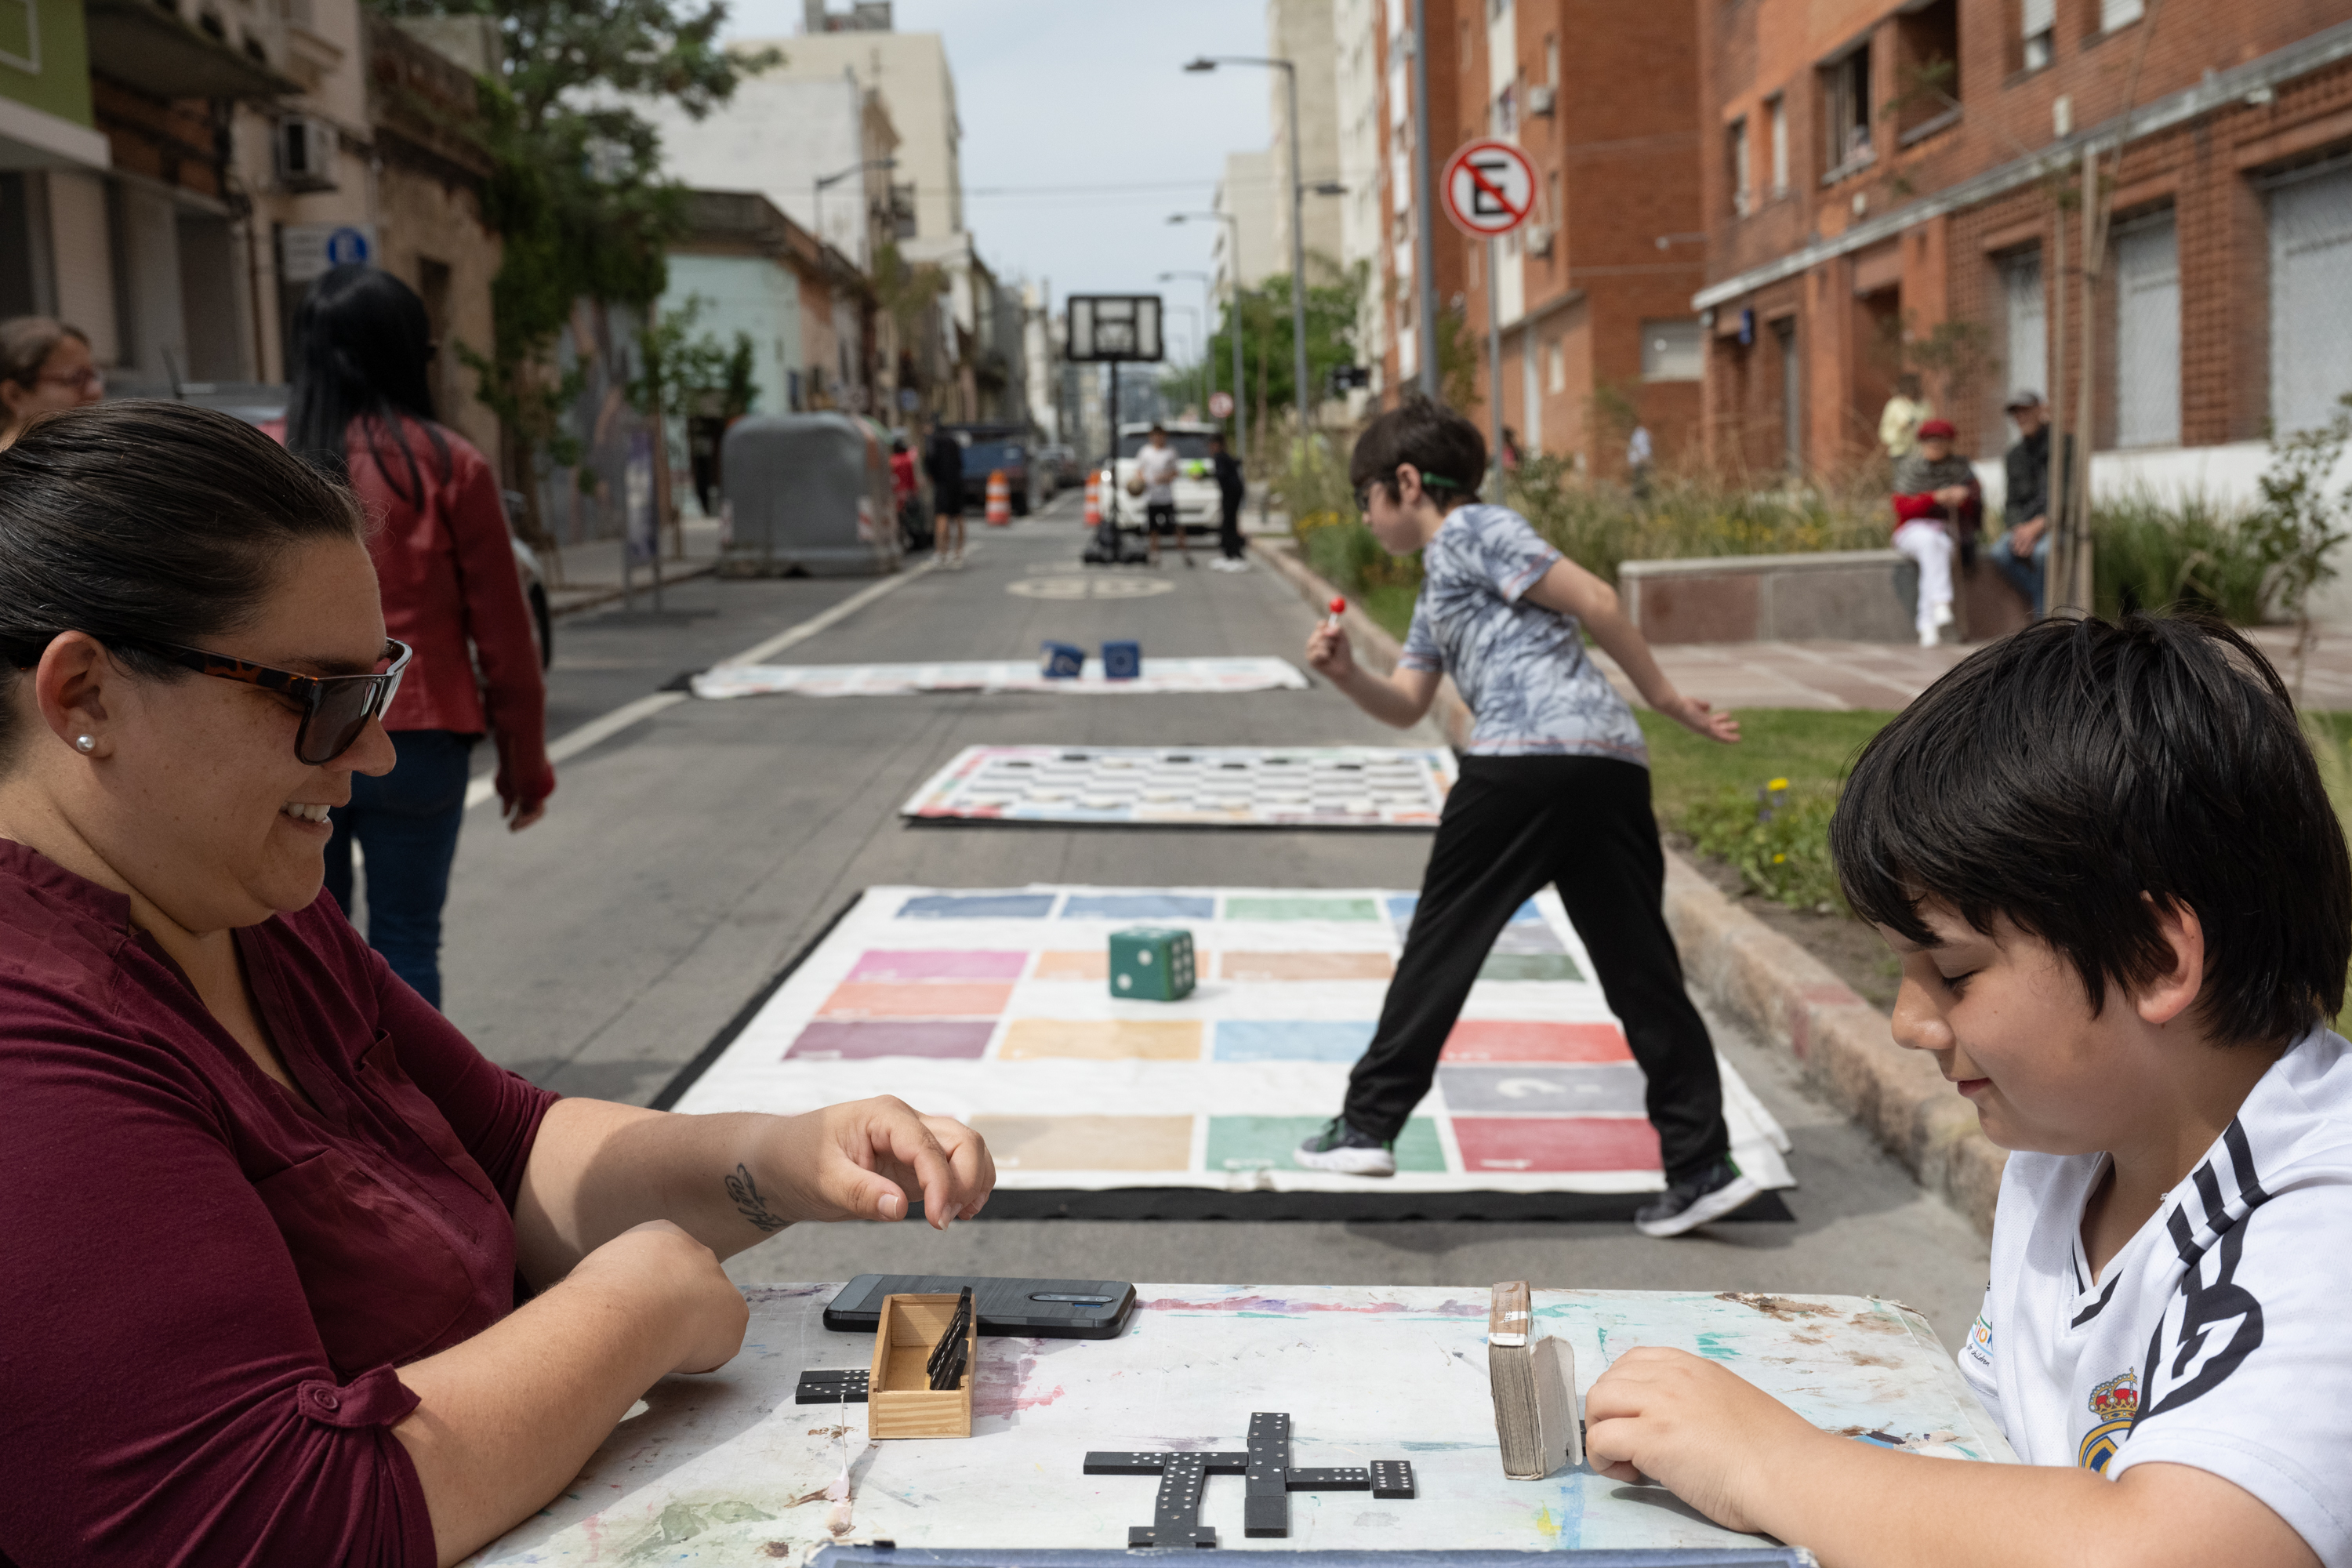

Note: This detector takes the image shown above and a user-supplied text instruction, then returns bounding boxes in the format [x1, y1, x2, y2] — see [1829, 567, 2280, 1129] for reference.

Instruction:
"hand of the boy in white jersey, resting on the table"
[1585, 1345, 1839, 1530]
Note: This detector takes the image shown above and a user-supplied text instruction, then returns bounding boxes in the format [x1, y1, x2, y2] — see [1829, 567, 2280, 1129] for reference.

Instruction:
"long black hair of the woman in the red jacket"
[287, 263, 449, 506]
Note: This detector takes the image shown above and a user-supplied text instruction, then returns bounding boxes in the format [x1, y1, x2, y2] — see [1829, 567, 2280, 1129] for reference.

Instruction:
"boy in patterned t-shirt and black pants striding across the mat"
[1296, 402, 1757, 1236]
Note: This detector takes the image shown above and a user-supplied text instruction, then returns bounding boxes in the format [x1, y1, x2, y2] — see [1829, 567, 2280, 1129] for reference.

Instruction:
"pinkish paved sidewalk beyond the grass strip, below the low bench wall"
[1592, 626, 2352, 710]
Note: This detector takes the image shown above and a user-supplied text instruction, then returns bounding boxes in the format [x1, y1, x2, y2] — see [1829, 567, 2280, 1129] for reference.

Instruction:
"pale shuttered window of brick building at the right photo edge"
[2270, 165, 2352, 430]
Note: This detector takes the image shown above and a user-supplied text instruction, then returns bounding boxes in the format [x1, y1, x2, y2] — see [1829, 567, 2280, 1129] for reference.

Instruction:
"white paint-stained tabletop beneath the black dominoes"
[473, 1283, 2016, 1568]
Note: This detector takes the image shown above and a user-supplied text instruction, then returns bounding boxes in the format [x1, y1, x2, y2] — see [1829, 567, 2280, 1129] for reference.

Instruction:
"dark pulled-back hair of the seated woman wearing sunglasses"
[0, 400, 365, 771]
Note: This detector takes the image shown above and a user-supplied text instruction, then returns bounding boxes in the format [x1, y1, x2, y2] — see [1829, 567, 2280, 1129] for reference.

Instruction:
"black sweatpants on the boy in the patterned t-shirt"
[1345, 757, 1731, 1182]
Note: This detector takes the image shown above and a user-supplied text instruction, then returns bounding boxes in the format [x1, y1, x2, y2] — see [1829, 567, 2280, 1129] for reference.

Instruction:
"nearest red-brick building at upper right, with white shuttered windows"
[1696, 0, 2352, 494]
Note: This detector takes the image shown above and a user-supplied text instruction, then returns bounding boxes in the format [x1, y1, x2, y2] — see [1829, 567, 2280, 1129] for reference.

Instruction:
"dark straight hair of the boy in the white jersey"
[1830, 616, 2352, 1044]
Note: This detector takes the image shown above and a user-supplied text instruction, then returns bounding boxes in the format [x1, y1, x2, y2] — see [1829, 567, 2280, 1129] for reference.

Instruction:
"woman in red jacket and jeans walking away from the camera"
[280, 266, 555, 1006]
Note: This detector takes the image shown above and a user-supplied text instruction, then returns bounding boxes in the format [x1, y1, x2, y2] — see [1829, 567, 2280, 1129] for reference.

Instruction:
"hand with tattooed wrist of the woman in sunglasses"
[760, 1095, 997, 1229]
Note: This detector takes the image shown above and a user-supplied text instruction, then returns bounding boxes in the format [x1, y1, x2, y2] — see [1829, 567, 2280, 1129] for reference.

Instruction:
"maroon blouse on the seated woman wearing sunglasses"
[0, 839, 555, 1568]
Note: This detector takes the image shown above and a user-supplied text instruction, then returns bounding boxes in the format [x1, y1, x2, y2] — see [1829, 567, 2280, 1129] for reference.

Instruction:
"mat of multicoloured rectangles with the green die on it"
[675, 884, 1795, 1192]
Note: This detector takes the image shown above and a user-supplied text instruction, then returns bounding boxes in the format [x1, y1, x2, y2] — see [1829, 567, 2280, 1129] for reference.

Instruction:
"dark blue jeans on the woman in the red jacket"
[327, 729, 480, 1006]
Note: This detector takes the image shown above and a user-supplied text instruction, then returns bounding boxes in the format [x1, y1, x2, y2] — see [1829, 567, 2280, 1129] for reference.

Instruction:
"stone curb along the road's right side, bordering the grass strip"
[1249, 541, 2009, 1236]
